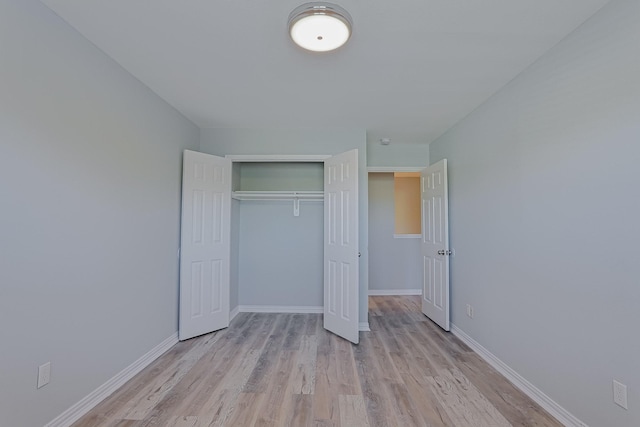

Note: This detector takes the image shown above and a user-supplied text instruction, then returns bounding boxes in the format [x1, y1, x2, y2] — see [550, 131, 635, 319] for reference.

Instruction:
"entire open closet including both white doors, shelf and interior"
[179, 149, 360, 344]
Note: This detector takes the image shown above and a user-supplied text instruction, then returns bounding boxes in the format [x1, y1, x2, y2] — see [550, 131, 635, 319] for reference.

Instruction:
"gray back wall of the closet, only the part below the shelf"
[238, 201, 324, 307]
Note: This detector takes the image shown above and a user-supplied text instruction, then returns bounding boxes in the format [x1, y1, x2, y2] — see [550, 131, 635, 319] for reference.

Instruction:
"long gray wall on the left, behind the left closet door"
[0, 0, 199, 426]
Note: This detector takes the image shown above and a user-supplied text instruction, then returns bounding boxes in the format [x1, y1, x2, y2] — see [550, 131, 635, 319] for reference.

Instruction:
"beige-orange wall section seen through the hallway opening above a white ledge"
[394, 174, 422, 234]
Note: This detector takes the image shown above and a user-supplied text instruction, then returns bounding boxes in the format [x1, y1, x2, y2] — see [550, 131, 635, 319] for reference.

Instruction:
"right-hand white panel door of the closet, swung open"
[324, 150, 359, 344]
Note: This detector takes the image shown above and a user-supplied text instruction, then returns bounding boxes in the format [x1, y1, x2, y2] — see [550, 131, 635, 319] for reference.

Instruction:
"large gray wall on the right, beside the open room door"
[431, 0, 640, 427]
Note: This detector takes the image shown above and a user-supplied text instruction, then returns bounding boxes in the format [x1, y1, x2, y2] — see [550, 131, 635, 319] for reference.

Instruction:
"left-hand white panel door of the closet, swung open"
[179, 150, 231, 340]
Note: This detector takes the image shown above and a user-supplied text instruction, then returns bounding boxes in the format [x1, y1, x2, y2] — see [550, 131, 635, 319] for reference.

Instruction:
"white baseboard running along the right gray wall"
[451, 324, 588, 427]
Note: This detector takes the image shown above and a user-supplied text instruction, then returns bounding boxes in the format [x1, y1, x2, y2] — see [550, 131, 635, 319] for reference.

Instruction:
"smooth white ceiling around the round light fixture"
[42, 0, 609, 143]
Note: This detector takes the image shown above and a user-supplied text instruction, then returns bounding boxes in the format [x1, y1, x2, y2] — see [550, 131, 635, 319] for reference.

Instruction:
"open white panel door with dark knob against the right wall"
[421, 159, 450, 331]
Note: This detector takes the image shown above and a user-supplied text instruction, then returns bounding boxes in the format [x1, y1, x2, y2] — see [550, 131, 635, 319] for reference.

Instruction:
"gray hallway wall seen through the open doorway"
[369, 173, 422, 291]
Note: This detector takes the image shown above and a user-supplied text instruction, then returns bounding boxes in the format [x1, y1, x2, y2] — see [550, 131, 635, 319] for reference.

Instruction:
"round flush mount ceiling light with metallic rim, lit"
[289, 2, 353, 52]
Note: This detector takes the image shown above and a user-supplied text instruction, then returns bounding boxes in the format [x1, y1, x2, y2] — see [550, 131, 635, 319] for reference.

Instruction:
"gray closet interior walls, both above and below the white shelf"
[231, 162, 324, 310]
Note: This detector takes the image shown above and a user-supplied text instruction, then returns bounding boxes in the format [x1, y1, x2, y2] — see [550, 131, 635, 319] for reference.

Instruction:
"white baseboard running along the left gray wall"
[45, 332, 178, 427]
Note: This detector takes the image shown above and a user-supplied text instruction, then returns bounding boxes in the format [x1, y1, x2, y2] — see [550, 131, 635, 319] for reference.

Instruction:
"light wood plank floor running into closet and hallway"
[74, 296, 561, 427]
